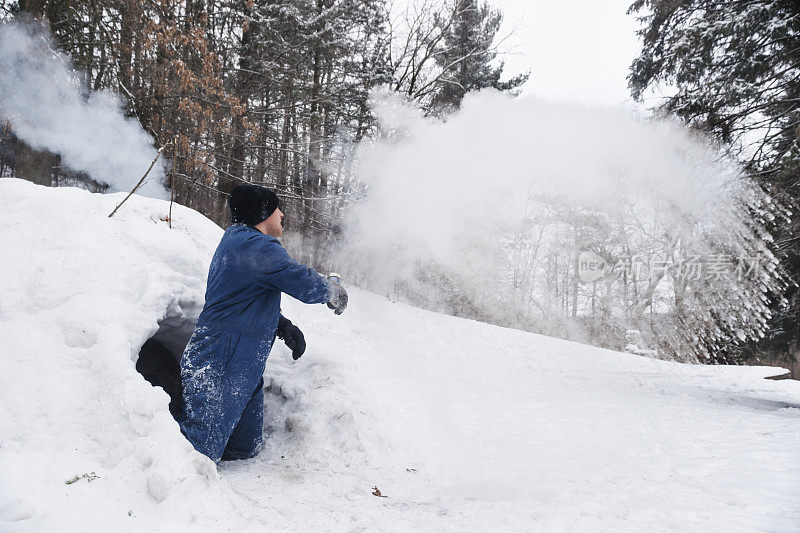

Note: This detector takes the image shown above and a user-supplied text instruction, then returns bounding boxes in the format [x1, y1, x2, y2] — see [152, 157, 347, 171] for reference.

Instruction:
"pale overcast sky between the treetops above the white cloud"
[489, 0, 639, 104]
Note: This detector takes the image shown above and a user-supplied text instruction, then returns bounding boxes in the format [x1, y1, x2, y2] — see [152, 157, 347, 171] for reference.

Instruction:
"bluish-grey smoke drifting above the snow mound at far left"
[0, 23, 168, 198]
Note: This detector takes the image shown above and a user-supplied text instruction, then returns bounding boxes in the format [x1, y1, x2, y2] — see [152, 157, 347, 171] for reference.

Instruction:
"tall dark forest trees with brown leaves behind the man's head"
[0, 0, 527, 236]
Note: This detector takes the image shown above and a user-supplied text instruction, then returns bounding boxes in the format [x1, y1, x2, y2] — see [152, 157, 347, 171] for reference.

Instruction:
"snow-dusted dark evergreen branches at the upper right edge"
[629, 0, 800, 366]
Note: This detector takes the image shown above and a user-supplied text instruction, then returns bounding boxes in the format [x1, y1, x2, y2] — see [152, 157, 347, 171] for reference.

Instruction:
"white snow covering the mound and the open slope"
[0, 179, 800, 531]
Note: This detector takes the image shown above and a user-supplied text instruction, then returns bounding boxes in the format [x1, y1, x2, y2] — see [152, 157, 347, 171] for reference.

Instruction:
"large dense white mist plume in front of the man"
[351, 91, 742, 268]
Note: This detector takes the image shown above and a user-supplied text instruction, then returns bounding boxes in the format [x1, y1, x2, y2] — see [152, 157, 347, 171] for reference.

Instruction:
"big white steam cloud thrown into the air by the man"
[340, 88, 750, 320]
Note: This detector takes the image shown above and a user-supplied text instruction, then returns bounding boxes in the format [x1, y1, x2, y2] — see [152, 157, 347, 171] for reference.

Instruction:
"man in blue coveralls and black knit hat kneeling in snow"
[178, 184, 347, 462]
